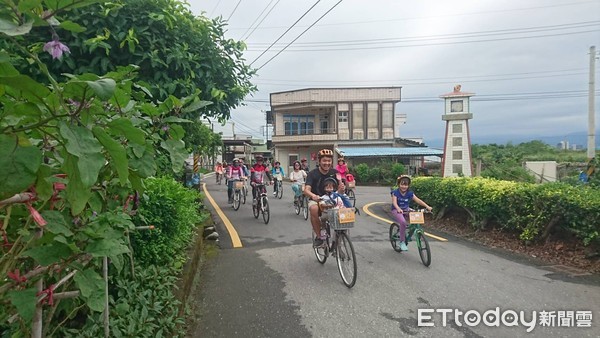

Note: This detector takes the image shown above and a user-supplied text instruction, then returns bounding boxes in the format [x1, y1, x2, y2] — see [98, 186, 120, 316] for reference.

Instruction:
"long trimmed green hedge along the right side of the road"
[411, 177, 600, 245]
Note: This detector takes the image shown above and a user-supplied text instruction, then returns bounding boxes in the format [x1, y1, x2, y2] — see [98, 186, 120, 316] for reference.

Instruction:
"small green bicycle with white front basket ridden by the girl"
[389, 209, 431, 266]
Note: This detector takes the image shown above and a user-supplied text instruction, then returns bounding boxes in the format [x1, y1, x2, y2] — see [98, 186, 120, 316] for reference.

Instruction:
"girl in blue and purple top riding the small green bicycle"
[391, 175, 432, 251]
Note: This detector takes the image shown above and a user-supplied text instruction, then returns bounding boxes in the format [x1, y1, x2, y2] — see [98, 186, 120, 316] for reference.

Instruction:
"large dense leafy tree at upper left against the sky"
[0, 0, 256, 122]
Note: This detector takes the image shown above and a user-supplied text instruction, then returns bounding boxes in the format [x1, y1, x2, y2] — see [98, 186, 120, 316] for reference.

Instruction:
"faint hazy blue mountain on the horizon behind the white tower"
[425, 130, 600, 150]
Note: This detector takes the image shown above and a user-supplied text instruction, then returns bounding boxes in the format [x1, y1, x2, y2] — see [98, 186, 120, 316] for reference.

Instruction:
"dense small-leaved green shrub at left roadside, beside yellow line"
[131, 177, 206, 266]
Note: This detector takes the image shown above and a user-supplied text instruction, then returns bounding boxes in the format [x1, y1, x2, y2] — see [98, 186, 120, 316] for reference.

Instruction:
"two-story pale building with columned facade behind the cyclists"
[270, 87, 441, 170]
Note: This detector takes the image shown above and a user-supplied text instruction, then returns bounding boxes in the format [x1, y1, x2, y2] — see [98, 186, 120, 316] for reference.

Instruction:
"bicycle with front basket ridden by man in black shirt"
[311, 198, 357, 288]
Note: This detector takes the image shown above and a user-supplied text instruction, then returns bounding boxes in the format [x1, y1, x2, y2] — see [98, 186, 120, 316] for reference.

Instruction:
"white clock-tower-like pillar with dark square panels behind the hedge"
[440, 85, 475, 177]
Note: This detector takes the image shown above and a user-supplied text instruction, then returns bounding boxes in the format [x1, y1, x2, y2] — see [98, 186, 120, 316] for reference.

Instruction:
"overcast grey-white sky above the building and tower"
[188, 0, 600, 145]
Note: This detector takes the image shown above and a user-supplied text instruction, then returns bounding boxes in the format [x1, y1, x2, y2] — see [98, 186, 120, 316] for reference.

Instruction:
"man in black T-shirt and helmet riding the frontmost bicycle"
[304, 149, 346, 247]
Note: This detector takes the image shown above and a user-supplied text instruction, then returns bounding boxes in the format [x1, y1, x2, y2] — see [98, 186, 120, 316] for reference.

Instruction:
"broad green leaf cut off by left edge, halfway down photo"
[0, 135, 42, 200]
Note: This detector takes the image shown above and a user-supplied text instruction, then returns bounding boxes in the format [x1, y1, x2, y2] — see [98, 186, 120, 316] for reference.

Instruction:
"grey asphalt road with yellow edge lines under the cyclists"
[193, 176, 600, 337]
